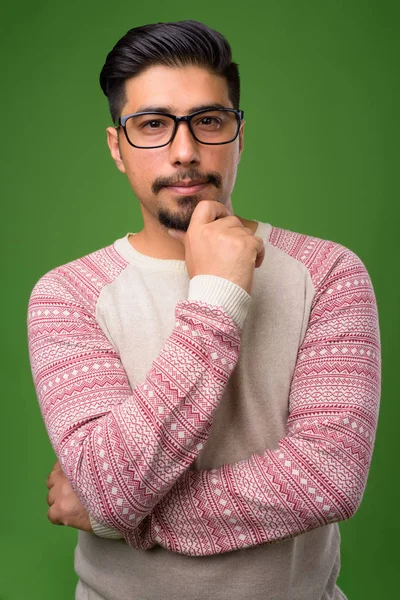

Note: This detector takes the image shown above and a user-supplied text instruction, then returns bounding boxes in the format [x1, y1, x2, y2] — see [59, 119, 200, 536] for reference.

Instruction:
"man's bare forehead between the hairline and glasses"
[122, 65, 232, 115]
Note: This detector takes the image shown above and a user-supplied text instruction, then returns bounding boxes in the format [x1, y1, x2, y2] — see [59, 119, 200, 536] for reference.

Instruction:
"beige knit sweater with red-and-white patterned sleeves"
[28, 222, 380, 600]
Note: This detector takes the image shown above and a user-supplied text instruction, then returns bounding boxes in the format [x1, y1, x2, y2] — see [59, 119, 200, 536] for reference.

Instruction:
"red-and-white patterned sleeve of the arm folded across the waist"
[141, 249, 380, 555]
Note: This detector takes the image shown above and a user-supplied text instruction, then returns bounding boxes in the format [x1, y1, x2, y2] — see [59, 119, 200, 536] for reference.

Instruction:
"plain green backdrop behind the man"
[0, 0, 400, 600]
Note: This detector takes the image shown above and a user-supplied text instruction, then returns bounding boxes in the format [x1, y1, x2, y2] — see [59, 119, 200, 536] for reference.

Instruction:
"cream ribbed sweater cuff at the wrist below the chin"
[188, 275, 251, 328]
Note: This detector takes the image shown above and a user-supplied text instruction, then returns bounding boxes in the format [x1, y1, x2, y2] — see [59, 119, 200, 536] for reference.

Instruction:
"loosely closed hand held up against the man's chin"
[168, 200, 265, 294]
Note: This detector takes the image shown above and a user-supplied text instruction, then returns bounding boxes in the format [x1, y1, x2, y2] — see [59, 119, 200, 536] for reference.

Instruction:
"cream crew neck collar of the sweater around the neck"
[114, 220, 272, 274]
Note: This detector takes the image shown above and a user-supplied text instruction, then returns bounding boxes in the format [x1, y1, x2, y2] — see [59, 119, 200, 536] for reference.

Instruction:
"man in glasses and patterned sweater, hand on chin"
[28, 21, 380, 600]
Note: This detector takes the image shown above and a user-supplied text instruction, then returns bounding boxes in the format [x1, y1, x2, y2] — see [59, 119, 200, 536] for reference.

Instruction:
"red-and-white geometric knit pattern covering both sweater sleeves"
[28, 227, 381, 556]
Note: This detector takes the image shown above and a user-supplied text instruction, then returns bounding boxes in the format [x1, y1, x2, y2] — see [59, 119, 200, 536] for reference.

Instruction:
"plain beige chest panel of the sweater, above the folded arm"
[102, 255, 312, 469]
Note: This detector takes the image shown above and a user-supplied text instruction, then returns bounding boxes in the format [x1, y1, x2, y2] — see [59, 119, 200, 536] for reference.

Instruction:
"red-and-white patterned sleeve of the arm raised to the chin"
[28, 241, 240, 531]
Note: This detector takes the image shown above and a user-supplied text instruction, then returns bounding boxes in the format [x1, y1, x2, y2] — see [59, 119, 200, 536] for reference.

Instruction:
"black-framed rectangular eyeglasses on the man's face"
[118, 108, 244, 148]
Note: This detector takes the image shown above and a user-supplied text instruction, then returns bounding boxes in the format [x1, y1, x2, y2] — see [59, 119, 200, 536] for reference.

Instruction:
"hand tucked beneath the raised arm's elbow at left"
[46, 461, 93, 532]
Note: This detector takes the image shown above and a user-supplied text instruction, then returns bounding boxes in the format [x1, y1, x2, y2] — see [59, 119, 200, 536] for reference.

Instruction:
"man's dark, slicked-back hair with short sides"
[100, 21, 240, 123]
